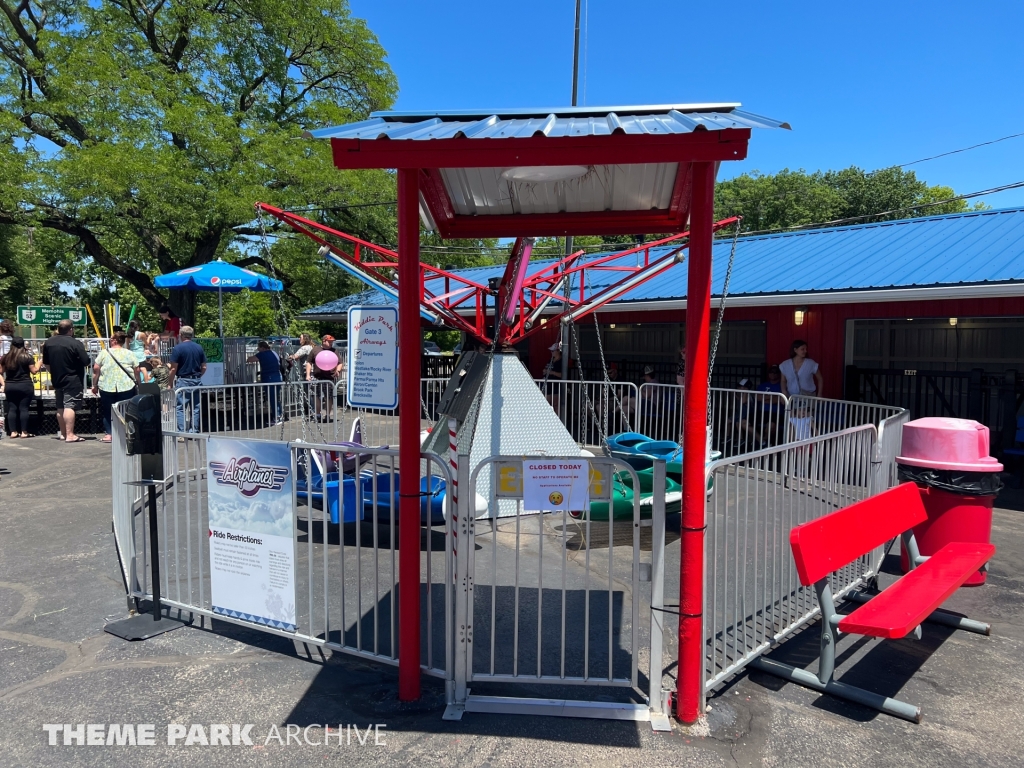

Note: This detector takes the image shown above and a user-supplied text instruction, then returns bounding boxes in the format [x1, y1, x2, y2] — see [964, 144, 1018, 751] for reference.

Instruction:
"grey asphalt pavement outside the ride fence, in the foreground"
[0, 437, 1024, 768]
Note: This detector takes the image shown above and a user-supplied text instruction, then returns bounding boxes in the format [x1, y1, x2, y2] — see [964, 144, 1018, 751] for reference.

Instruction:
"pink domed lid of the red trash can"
[896, 417, 1002, 472]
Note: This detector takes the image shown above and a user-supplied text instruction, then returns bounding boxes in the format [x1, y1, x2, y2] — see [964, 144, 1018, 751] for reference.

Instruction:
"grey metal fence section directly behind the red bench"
[703, 421, 906, 691]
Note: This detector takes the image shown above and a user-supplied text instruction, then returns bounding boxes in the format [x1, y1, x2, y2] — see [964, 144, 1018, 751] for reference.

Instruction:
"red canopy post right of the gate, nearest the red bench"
[676, 163, 715, 723]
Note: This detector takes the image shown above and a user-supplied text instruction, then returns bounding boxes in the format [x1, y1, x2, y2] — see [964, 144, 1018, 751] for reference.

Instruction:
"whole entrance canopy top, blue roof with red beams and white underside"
[306, 103, 790, 238]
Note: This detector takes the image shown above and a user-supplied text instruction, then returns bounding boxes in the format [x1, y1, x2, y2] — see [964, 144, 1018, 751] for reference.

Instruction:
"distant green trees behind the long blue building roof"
[715, 166, 969, 231]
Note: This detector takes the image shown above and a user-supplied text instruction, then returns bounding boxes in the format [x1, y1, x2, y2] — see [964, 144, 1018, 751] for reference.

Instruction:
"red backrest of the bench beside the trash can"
[790, 482, 928, 587]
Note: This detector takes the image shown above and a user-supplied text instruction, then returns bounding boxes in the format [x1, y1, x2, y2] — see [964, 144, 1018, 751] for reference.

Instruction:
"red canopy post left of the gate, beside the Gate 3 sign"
[398, 168, 421, 701]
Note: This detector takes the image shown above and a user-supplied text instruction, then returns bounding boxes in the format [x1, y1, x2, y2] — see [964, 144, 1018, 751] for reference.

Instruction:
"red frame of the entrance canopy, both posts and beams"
[296, 110, 761, 723]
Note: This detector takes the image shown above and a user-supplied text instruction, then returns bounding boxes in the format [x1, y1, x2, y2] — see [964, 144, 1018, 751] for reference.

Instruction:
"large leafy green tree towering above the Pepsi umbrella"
[0, 0, 397, 319]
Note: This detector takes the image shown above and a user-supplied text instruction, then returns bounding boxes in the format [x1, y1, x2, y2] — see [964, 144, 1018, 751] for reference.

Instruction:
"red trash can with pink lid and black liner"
[896, 417, 1002, 587]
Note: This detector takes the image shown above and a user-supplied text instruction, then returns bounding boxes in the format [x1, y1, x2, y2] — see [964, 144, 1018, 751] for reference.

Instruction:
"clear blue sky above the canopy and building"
[351, 0, 1024, 208]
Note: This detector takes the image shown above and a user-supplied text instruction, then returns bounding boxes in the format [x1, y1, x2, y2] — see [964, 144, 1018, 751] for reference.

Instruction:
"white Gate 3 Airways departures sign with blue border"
[347, 306, 398, 408]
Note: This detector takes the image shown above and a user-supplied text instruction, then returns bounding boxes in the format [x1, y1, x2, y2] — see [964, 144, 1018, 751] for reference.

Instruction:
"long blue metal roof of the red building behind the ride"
[303, 208, 1024, 315]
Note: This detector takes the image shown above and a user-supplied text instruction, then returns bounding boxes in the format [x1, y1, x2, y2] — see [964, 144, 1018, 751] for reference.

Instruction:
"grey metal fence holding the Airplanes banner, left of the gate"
[113, 403, 453, 679]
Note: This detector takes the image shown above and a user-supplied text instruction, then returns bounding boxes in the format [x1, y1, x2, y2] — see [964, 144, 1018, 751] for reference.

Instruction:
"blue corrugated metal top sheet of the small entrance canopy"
[306, 103, 790, 140]
